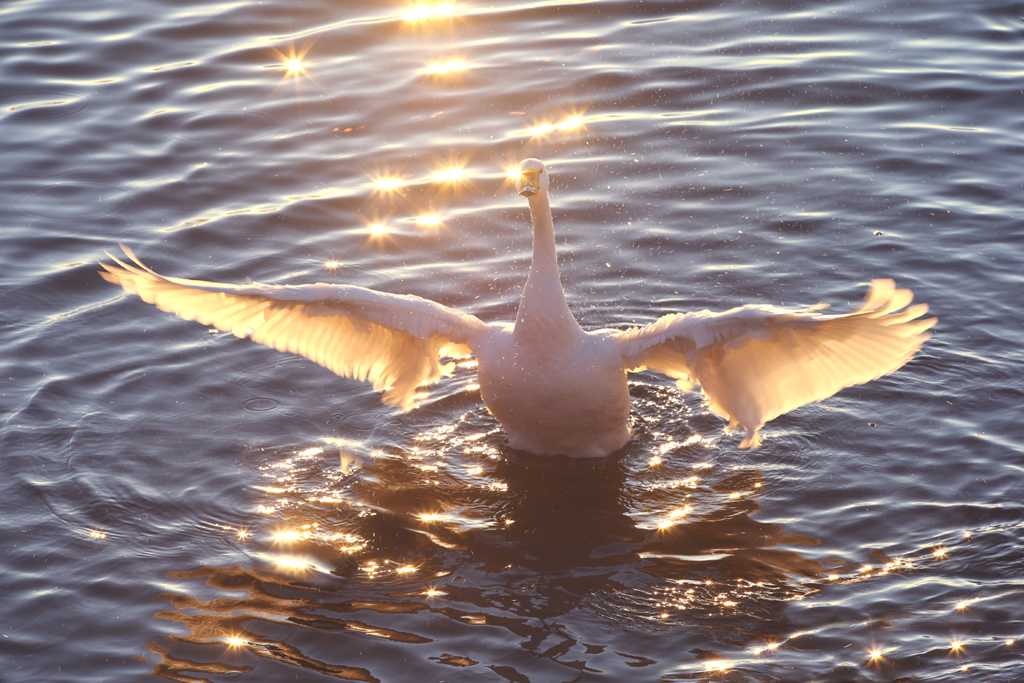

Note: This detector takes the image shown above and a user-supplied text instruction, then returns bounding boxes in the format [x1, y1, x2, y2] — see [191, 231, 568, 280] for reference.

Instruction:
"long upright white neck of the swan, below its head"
[515, 191, 583, 344]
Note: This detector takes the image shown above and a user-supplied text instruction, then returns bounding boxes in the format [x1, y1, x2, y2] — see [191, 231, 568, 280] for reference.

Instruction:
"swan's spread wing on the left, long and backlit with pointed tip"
[100, 245, 488, 410]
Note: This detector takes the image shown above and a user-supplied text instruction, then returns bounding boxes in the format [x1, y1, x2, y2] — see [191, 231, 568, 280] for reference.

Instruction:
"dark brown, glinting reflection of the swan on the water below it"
[150, 392, 824, 681]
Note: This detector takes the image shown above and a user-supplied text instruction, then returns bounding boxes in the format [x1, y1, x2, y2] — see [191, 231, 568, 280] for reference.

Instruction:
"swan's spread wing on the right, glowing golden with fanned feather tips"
[614, 280, 938, 447]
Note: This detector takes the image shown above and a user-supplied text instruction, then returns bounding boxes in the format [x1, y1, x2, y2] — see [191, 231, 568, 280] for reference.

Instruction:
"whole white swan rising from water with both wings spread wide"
[100, 159, 937, 457]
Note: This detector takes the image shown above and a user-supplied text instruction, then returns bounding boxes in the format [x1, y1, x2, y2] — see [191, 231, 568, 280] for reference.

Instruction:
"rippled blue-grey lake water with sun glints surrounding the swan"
[0, 0, 1024, 683]
